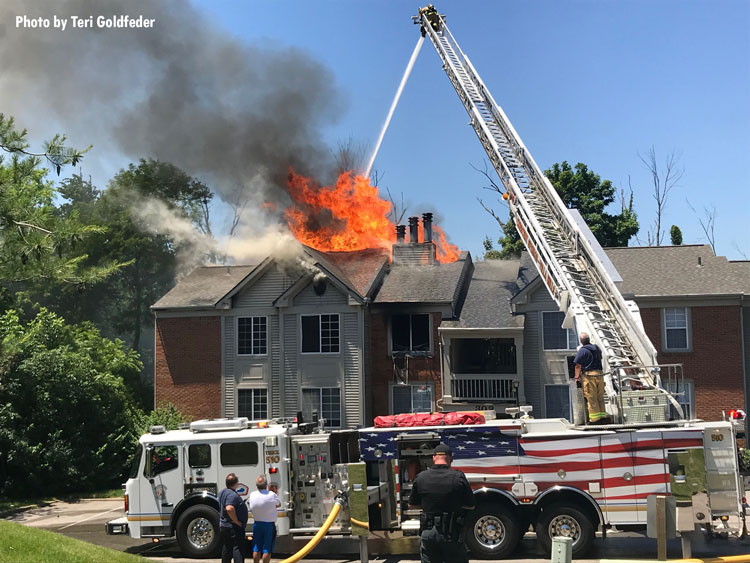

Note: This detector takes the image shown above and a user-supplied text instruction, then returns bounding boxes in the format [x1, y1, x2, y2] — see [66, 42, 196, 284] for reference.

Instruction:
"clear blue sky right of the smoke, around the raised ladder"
[197, 0, 750, 259]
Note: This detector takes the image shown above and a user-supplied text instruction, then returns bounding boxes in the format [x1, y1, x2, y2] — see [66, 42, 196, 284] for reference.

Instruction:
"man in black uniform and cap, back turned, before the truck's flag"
[409, 444, 474, 563]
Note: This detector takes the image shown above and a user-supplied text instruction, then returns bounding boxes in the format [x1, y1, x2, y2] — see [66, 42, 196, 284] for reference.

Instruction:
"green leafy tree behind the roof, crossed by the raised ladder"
[480, 161, 639, 258]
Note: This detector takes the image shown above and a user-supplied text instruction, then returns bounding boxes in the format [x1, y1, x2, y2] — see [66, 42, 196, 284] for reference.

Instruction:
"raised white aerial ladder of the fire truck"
[413, 5, 684, 423]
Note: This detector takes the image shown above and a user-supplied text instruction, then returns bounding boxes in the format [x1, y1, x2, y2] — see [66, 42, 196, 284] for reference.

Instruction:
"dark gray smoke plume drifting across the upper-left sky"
[0, 0, 343, 206]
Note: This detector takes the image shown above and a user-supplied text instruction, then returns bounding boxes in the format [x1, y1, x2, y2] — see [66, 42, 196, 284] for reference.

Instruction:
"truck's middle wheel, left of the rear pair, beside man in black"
[464, 504, 520, 559]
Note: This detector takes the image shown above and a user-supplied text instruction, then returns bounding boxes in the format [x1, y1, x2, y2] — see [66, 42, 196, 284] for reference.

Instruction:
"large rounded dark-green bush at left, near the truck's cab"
[0, 309, 143, 496]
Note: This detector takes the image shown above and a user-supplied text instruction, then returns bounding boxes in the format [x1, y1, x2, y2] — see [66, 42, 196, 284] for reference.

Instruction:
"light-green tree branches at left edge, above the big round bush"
[0, 114, 119, 286]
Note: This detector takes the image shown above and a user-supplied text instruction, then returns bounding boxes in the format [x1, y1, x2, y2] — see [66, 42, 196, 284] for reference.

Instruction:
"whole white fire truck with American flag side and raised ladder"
[107, 6, 745, 558]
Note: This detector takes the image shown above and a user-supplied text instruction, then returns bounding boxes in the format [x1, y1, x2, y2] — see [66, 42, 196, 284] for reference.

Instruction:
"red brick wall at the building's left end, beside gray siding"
[154, 317, 221, 420]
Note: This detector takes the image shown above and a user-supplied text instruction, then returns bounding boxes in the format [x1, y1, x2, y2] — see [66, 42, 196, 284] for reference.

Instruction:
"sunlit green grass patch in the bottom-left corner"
[0, 521, 153, 563]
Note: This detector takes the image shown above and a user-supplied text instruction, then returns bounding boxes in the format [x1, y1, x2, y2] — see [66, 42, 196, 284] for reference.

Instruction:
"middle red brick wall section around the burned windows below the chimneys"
[365, 309, 443, 424]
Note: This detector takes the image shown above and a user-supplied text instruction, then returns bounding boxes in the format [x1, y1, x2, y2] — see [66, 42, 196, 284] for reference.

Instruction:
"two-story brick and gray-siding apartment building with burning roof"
[153, 217, 750, 427]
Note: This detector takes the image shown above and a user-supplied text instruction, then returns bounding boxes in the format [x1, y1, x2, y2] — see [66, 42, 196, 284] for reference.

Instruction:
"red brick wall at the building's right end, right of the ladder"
[641, 306, 747, 420]
